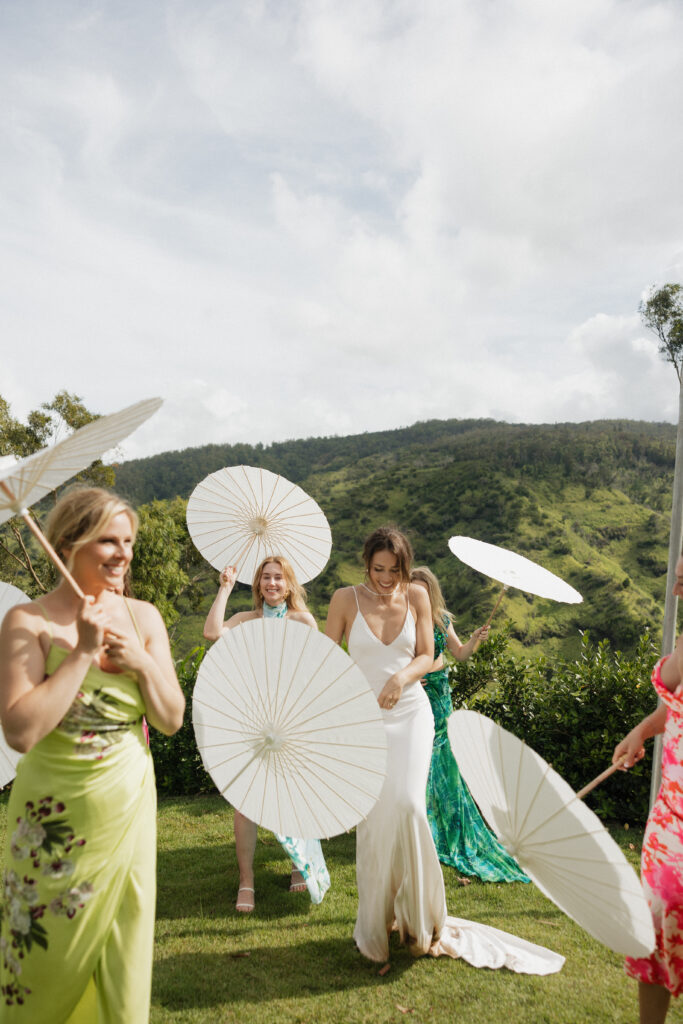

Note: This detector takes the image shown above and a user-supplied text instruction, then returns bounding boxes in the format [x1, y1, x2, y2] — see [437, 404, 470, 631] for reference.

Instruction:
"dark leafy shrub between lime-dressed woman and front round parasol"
[150, 647, 215, 796]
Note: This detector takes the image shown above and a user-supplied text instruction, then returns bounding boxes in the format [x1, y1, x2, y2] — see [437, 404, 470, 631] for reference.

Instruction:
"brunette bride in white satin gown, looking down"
[326, 526, 564, 974]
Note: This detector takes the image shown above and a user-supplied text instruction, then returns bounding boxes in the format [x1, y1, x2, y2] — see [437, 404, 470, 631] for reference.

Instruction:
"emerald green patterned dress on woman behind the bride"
[425, 621, 529, 882]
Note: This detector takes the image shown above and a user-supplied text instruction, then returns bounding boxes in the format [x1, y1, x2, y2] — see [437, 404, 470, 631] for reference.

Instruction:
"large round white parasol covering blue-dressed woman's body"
[193, 618, 386, 839]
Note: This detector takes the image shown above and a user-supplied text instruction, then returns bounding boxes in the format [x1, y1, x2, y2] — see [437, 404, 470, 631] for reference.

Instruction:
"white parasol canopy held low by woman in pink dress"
[449, 711, 654, 956]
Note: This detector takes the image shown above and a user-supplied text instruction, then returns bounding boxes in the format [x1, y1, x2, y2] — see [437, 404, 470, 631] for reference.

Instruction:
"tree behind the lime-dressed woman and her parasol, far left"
[0, 391, 115, 597]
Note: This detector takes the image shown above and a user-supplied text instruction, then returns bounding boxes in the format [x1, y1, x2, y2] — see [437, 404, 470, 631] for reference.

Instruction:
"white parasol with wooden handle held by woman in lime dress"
[0, 398, 162, 597]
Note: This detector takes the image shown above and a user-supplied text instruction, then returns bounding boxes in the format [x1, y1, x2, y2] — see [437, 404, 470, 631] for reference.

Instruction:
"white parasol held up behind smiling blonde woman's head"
[187, 466, 332, 584]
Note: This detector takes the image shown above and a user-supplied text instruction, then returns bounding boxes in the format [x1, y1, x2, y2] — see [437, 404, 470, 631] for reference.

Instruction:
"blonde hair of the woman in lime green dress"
[45, 487, 138, 571]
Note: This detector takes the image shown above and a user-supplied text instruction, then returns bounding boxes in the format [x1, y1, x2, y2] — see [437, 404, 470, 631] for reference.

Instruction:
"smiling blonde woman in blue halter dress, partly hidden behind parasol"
[204, 555, 330, 913]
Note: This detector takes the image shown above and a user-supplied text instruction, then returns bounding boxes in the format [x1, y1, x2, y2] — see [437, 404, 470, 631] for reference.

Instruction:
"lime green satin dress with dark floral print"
[0, 643, 157, 1024]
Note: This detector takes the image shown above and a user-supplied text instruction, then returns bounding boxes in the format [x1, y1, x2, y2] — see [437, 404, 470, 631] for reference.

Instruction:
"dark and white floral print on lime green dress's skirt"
[0, 797, 94, 1006]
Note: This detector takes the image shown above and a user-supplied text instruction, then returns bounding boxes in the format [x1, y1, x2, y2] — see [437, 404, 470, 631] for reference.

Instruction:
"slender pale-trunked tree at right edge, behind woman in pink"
[638, 284, 683, 806]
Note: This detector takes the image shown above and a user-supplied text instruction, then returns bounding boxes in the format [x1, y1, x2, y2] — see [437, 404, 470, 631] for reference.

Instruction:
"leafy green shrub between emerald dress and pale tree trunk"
[453, 630, 657, 822]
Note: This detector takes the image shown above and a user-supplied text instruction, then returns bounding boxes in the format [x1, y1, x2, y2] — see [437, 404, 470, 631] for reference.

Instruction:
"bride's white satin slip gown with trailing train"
[348, 590, 564, 974]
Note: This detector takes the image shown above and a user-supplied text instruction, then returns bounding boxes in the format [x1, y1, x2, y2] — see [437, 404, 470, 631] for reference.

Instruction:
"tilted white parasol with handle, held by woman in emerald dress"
[449, 537, 584, 626]
